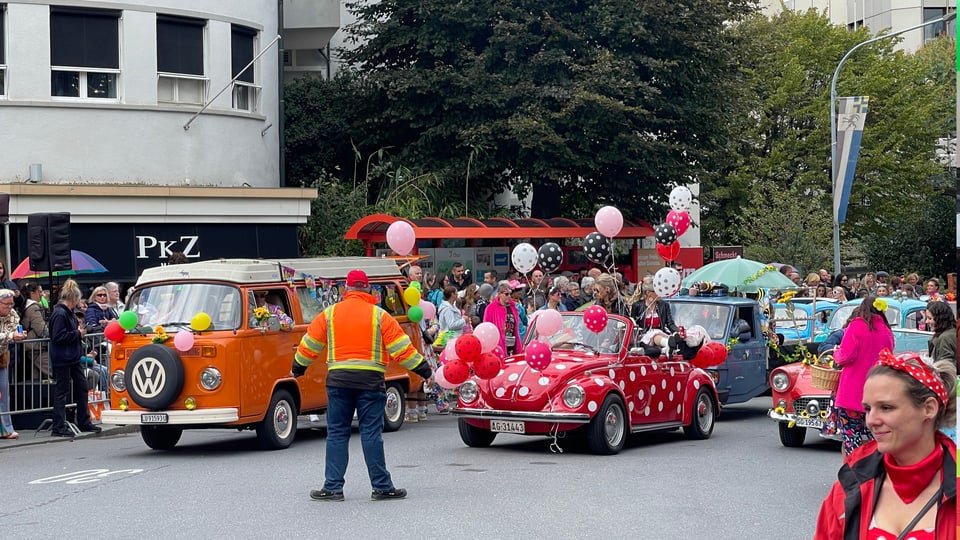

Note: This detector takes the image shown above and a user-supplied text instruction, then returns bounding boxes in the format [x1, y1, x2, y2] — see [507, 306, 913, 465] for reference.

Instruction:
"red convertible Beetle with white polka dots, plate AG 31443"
[452, 312, 719, 454]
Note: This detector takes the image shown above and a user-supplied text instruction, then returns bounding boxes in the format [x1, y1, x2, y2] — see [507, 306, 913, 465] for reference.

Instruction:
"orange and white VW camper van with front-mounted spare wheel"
[102, 257, 423, 450]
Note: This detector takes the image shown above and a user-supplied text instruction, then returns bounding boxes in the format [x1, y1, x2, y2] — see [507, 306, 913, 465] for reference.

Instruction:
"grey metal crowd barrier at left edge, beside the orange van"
[9, 333, 110, 429]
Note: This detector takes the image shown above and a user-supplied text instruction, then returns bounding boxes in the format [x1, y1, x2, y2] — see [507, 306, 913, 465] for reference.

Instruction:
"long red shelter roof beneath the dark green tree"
[344, 214, 653, 245]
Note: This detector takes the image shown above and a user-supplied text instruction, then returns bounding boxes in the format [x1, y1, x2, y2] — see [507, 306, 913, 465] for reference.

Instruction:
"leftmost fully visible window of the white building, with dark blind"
[50, 7, 120, 100]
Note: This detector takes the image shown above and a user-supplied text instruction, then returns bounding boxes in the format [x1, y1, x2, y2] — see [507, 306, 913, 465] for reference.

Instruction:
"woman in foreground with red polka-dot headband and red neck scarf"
[814, 349, 957, 540]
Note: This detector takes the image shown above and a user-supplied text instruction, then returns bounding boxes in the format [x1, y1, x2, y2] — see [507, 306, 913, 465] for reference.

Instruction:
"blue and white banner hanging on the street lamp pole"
[833, 96, 870, 223]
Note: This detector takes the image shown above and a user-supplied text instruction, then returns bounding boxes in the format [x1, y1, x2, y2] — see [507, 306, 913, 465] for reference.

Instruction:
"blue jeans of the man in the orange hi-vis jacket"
[323, 386, 393, 492]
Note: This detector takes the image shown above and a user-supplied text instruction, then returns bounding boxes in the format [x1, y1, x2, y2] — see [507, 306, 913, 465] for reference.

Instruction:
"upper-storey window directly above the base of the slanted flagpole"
[157, 14, 209, 105]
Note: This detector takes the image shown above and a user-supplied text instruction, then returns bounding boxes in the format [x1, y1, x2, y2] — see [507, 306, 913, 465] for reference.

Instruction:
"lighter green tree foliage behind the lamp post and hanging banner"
[700, 11, 956, 269]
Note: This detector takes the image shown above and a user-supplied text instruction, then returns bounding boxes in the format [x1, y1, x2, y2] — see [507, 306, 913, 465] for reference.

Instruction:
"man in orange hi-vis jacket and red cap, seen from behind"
[291, 270, 433, 501]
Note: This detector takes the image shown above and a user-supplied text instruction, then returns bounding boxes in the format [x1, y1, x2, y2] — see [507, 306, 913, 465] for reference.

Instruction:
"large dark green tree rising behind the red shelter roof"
[334, 0, 752, 219]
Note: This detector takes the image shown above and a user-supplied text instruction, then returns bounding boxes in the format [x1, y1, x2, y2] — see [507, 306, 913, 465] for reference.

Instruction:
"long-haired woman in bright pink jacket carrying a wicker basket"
[833, 296, 893, 457]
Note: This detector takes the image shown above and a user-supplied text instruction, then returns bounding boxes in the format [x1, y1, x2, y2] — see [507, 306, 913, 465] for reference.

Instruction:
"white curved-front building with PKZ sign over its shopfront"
[0, 0, 339, 281]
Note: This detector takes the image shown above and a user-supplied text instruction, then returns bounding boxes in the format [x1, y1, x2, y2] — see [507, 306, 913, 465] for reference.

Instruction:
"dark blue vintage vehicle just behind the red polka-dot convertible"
[667, 292, 775, 405]
